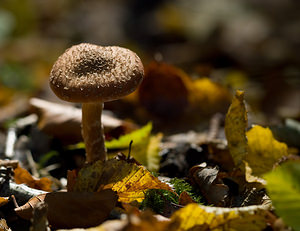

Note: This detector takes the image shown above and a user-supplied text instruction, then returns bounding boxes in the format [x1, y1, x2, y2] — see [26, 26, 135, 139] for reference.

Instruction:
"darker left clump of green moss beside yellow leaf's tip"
[140, 189, 178, 214]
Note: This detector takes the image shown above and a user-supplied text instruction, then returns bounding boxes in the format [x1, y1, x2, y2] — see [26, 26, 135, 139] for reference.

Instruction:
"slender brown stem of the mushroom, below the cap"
[81, 102, 106, 163]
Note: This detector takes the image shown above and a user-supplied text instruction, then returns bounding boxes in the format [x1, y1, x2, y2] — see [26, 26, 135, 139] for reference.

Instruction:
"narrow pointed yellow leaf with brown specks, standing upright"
[225, 91, 248, 167]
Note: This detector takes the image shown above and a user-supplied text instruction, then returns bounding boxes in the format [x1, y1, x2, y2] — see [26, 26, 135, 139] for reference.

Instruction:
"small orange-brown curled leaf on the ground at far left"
[14, 166, 52, 192]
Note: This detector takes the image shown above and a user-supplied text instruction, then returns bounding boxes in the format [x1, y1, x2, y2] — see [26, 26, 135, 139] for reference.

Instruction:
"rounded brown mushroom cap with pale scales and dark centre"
[50, 43, 144, 103]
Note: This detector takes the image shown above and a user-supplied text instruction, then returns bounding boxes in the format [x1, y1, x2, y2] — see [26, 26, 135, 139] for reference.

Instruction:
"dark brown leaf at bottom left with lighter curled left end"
[15, 190, 117, 228]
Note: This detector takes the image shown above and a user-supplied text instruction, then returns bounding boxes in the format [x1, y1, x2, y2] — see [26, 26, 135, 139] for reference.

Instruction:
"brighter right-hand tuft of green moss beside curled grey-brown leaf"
[170, 178, 203, 204]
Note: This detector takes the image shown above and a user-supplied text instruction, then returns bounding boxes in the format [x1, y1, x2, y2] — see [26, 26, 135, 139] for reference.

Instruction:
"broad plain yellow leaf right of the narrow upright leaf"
[245, 125, 288, 176]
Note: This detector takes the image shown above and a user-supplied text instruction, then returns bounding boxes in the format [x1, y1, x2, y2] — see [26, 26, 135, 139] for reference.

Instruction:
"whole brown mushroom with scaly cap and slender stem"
[50, 43, 144, 163]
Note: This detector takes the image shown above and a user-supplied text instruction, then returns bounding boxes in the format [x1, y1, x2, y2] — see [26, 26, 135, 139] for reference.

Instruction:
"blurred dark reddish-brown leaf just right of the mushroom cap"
[138, 62, 190, 118]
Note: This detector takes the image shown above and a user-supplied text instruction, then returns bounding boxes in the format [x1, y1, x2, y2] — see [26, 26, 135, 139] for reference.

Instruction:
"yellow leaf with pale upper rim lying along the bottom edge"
[170, 204, 267, 231]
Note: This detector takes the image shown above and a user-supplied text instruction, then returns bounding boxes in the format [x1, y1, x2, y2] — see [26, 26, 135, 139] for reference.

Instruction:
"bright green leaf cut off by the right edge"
[264, 162, 300, 230]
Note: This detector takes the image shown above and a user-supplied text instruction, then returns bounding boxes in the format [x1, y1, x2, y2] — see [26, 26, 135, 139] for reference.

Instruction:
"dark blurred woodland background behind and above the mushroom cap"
[0, 0, 300, 119]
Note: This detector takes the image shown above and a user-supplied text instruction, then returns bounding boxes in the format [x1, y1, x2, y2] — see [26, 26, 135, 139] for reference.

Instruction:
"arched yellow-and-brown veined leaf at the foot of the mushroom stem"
[68, 156, 172, 203]
